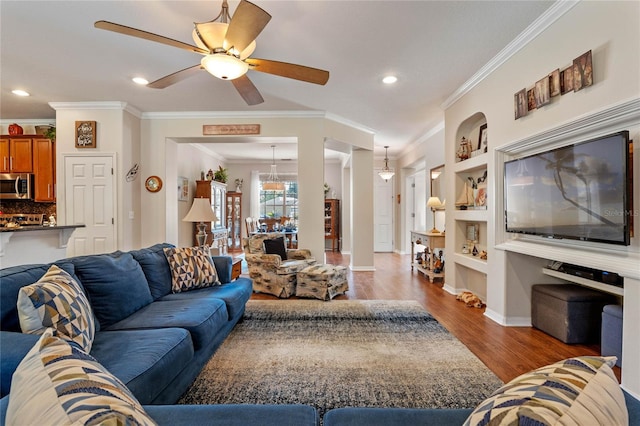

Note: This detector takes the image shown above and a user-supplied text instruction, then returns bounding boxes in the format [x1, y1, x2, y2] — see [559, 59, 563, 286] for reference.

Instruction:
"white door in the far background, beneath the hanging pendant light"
[373, 172, 393, 252]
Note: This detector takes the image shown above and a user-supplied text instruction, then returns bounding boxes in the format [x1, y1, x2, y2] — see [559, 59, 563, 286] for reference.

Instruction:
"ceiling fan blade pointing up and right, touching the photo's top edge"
[225, 0, 271, 52]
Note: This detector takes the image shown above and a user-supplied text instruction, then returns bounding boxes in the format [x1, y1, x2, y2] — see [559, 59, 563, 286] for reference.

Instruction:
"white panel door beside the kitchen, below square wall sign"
[64, 155, 116, 256]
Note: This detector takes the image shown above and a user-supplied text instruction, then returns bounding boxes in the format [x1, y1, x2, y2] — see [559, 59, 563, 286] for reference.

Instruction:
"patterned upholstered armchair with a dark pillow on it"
[243, 232, 316, 298]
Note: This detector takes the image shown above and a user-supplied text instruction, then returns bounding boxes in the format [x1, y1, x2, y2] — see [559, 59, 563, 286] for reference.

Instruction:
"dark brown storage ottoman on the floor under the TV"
[531, 284, 615, 344]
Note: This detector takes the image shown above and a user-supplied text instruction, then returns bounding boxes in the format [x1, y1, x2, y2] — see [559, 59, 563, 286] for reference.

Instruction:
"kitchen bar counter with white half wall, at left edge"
[0, 225, 85, 268]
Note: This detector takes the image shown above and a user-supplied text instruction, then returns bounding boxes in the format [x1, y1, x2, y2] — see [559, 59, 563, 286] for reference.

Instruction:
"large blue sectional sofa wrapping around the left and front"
[0, 244, 640, 426]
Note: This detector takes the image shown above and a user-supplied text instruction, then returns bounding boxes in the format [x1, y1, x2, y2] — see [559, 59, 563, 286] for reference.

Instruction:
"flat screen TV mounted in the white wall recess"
[504, 131, 631, 245]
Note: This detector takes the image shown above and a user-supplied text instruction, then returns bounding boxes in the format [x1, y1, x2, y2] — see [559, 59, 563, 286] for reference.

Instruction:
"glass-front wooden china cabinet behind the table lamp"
[193, 180, 229, 255]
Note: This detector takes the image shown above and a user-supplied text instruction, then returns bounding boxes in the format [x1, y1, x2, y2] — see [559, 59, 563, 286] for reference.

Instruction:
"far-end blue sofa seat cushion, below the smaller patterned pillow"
[159, 277, 253, 320]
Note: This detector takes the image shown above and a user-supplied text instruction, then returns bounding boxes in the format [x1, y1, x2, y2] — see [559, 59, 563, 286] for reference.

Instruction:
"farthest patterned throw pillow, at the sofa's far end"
[164, 246, 220, 293]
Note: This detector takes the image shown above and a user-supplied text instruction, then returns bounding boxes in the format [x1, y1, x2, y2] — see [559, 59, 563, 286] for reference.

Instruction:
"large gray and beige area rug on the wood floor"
[178, 300, 502, 416]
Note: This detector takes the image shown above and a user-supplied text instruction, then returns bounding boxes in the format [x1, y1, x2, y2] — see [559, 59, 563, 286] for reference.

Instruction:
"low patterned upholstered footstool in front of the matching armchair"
[296, 265, 349, 300]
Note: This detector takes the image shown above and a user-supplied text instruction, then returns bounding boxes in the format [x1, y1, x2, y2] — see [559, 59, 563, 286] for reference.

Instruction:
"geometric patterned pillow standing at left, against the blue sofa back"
[17, 265, 96, 352]
